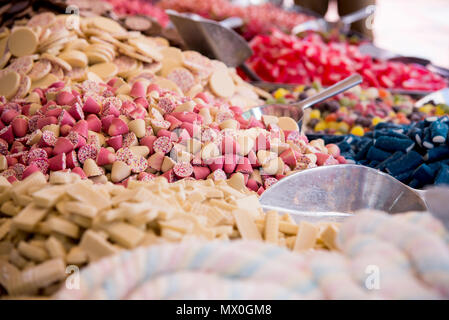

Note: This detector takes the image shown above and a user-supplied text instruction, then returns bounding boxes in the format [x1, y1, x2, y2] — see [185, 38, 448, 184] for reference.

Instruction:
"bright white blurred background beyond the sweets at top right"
[320, 0, 449, 68]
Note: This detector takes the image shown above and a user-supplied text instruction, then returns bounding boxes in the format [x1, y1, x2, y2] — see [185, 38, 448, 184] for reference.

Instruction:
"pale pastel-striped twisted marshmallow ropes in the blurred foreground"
[54, 212, 449, 299]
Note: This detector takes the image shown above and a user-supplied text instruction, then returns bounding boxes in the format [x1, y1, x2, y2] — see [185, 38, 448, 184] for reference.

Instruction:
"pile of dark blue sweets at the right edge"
[311, 116, 449, 188]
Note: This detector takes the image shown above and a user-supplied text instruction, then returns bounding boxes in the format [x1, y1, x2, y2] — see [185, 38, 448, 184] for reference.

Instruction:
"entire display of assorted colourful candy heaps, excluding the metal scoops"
[0, 0, 449, 307]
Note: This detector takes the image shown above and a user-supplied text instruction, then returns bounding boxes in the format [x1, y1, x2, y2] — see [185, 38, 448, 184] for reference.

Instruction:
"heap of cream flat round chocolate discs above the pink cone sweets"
[0, 12, 269, 108]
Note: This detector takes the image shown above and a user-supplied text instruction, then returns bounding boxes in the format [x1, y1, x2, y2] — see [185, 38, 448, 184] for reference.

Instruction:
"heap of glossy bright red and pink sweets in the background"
[248, 30, 447, 91]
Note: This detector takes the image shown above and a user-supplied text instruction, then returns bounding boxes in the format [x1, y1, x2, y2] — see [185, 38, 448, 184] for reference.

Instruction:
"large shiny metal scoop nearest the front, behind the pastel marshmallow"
[260, 164, 449, 227]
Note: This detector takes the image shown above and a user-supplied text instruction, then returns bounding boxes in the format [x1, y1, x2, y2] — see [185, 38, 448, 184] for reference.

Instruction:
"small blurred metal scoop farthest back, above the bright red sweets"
[291, 5, 376, 34]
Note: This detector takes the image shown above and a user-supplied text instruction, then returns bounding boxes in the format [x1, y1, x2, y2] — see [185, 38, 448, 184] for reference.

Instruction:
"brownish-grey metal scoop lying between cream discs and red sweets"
[166, 10, 261, 81]
